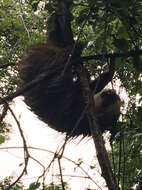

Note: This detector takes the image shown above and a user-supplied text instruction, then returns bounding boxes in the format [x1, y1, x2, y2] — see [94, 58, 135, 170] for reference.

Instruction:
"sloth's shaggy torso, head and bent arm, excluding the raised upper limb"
[20, 42, 120, 137]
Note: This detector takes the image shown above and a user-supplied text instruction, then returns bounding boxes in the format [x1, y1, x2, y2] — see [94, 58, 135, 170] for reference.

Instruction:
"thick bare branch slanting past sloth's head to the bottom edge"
[79, 64, 119, 190]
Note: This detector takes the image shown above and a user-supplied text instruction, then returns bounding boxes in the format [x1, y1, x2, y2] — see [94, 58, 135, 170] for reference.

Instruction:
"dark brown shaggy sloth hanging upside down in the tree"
[19, 0, 120, 137]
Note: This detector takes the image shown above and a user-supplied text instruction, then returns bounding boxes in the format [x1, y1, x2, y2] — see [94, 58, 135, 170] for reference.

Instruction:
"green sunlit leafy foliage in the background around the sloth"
[0, 0, 142, 190]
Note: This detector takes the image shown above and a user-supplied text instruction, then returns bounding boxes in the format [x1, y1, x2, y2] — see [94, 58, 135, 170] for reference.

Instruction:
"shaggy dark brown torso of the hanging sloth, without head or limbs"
[20, 43, 90, 136]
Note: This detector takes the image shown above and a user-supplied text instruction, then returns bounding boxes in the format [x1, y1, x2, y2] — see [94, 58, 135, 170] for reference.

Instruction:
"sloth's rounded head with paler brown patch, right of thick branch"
[94, 89, 120, 130]
